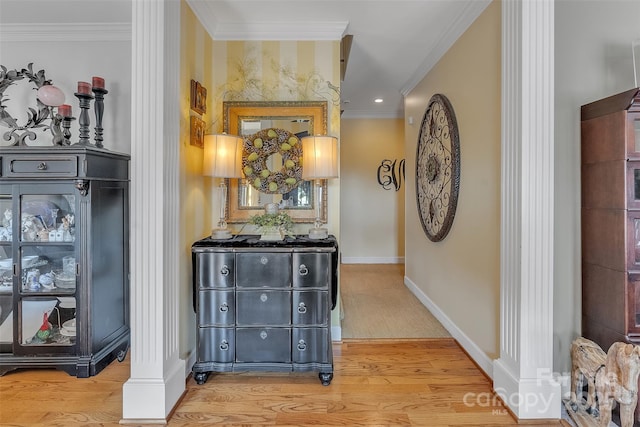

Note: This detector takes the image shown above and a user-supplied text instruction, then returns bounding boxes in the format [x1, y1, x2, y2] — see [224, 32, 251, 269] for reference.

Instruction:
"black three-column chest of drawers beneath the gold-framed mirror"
[192, 235, 338, 385]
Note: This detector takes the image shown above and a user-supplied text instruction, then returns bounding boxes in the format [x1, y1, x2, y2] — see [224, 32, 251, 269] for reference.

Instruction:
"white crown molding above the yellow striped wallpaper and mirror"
[187, 0, 349, 41]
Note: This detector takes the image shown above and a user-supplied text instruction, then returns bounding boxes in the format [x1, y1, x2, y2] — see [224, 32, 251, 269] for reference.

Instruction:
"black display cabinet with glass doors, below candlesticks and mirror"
[0, 146, 129, 377]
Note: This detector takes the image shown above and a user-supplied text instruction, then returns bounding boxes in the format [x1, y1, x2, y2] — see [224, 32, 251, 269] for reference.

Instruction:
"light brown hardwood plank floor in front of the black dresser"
[0, 338, 562, 427]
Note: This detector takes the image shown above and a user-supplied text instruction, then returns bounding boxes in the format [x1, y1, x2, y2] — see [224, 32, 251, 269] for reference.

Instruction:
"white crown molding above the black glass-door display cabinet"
[0, 23, 131, 42]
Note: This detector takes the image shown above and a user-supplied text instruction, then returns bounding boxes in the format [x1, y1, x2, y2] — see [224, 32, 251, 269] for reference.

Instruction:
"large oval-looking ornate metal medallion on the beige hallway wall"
[416, 94, 460, 242]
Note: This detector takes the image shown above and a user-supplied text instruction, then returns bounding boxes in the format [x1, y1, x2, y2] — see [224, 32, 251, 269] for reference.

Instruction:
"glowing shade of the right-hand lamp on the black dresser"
[301, 135, 338, 179]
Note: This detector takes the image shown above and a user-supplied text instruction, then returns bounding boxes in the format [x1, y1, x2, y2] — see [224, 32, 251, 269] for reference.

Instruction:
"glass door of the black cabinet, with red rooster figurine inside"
[14, 189, 78, 354]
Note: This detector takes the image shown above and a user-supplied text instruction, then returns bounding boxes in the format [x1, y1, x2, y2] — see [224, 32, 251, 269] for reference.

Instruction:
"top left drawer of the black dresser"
[195, 252, 235, 289]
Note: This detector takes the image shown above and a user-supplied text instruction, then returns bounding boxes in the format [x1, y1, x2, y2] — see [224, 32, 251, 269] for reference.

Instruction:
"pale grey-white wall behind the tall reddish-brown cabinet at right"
[554, 0, 640, 372]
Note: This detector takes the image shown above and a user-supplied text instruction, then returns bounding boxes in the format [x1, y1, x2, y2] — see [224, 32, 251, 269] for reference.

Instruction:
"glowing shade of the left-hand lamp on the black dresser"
[202, 134, 242, 178]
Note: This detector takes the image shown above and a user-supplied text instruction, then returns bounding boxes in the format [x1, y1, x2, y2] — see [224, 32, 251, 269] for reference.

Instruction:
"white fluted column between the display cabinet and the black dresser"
[121, 0, 185, 424]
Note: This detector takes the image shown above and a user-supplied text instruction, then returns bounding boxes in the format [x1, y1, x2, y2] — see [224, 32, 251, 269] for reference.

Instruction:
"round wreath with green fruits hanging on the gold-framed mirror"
[242, 128, 302, 194]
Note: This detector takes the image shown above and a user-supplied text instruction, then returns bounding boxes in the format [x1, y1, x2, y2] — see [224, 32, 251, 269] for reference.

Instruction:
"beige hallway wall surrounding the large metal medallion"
[405, 2, 501, 358]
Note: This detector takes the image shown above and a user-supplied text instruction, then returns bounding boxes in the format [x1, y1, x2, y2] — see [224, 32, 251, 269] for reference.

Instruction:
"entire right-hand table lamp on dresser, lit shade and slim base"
[301, 135, 338, 239]
